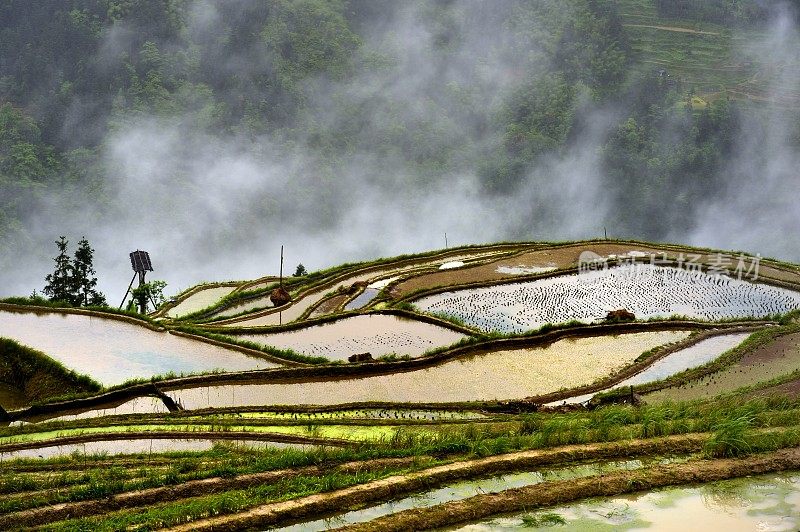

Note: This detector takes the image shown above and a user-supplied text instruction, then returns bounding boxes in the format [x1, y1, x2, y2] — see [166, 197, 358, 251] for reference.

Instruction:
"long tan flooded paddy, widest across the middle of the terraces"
[167, 331, 690, 410]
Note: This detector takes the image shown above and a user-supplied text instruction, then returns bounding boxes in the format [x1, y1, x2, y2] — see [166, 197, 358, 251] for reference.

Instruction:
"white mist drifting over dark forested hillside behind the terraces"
[0, 0, 800, 304]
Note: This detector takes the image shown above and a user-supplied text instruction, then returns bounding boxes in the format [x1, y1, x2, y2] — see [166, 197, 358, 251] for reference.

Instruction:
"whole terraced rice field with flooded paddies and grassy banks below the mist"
[0, 242, 800, 532]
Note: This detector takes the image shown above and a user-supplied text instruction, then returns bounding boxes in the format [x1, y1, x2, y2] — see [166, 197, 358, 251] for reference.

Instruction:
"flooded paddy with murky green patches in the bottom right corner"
[460, 472, 800, 532]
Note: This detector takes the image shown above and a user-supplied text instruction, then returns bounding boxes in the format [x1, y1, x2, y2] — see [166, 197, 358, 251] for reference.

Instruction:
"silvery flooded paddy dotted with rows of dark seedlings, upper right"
[414, 265, 800, 332]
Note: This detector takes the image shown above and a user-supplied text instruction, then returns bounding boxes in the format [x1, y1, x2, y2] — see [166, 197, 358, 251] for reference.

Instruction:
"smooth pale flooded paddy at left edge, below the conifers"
[0, 311, 278, 386]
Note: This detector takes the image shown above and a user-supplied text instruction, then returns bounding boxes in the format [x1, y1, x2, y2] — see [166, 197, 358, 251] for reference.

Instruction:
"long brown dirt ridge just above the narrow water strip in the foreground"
[161, 434, 708, 532]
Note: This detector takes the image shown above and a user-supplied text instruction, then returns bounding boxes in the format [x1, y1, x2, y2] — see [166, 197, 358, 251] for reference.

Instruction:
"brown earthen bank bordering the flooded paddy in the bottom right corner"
[338, 448, 800, 531]
